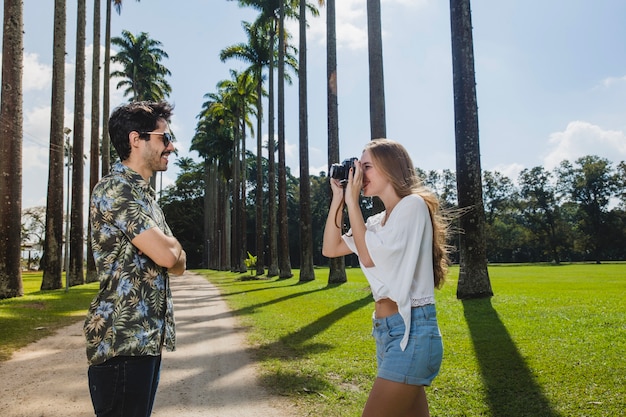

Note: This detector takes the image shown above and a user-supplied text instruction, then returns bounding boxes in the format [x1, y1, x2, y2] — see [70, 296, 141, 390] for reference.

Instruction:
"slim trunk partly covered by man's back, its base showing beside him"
[85, 0, 101, 282]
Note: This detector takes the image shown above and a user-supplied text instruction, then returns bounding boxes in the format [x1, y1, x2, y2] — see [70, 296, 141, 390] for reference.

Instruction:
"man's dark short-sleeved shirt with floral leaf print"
[84, 162, 176, 365]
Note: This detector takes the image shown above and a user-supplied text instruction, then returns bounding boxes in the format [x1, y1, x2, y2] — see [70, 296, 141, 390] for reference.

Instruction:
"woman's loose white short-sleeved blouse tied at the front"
[342, 194, 435, 350]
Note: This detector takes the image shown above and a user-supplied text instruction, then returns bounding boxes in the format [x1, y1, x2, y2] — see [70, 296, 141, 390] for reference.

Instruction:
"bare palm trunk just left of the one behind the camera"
[298, 1, 315, 282]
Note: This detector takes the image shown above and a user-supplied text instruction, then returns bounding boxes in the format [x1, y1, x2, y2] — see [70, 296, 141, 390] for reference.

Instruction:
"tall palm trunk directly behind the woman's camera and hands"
[326, 0, 348, 284]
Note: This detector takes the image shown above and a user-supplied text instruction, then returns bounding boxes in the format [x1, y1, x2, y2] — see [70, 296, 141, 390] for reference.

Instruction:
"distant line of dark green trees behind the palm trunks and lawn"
[161, 154, 626, 268]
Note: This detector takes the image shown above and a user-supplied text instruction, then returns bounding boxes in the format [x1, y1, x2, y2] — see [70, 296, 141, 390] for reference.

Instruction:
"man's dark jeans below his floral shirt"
[87, 356, 161, 417]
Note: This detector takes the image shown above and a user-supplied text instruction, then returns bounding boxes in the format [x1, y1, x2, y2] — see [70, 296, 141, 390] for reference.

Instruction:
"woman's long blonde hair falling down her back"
[364, 139, 449, 288]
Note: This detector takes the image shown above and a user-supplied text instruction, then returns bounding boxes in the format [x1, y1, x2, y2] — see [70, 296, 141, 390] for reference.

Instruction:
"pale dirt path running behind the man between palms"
[0, 272, 295, 417]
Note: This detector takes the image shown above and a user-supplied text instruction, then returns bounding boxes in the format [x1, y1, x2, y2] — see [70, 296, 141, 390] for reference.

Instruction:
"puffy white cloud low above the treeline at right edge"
[544, 121, 626, 170]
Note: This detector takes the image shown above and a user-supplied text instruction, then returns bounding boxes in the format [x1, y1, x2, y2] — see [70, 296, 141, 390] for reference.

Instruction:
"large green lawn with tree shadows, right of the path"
[200, 263, 626, 417]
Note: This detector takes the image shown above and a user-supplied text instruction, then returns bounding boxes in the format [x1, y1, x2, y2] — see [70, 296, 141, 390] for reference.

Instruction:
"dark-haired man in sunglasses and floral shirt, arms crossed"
[84, 102, 187, 417]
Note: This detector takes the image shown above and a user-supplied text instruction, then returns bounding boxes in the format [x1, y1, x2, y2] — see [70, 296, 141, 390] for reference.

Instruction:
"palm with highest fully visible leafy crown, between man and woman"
[220, 22, 273, 275]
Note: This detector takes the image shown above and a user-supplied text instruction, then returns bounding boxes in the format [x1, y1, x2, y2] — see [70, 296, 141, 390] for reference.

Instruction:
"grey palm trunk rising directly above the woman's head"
[367, 0, 387, 139]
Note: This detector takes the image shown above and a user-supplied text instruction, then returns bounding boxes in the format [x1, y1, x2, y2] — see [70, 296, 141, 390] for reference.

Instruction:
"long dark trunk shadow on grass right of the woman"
[463, 299, 560, 417]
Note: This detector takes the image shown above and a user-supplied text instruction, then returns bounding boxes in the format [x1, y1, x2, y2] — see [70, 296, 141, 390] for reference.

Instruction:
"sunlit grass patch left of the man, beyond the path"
[0, 272, 98, 361]
